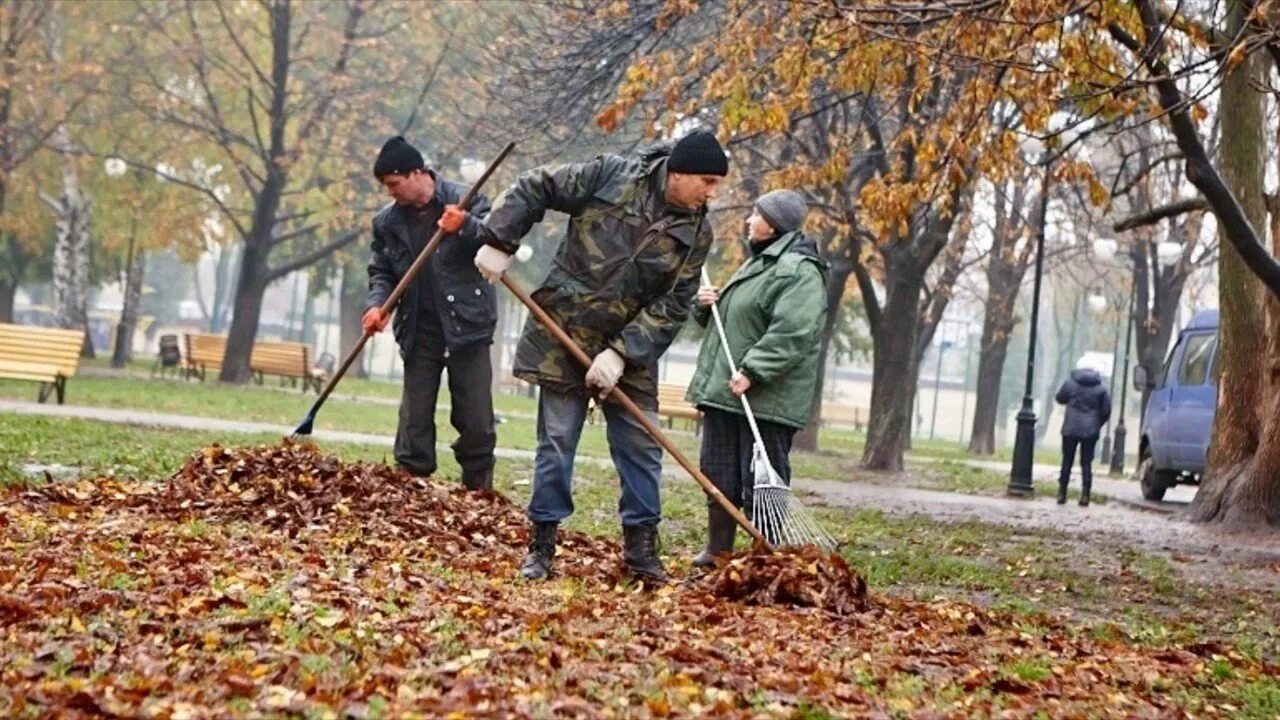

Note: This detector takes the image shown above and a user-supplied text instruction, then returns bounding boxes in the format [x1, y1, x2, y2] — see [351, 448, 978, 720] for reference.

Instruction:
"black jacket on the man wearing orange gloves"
[365, 174, 498, 356]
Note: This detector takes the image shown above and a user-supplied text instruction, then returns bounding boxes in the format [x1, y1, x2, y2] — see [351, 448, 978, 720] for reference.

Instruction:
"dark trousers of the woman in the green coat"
[698, 407, 796, 518]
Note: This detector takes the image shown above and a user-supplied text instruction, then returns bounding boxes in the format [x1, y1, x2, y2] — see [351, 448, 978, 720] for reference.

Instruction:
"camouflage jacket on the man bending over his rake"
[485, 147, 712, 410]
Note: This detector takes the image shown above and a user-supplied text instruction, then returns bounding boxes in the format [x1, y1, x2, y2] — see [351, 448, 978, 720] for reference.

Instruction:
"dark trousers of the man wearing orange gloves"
[396, 328, 498, 475]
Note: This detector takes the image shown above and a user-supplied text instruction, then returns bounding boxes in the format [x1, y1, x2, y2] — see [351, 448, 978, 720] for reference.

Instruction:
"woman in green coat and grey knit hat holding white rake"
[687, 190, 827, 568]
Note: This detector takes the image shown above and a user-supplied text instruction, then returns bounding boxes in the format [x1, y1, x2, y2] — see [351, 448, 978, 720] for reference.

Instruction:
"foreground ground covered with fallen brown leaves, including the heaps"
[0, 446, 1280, 717]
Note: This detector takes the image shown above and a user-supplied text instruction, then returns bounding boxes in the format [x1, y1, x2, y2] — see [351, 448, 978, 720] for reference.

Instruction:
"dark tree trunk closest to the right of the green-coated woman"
[863, 263, 924, 471]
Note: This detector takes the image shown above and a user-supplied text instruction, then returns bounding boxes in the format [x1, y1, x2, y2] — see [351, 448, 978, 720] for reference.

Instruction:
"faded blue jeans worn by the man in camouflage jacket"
[529, 387, 662, 525]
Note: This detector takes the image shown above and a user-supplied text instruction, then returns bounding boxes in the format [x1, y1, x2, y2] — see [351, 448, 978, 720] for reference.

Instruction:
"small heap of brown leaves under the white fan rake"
[703, 546, 869, 615]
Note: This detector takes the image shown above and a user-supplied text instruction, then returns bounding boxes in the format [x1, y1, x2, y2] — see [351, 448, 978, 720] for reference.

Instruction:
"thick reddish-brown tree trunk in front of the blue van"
[1189, 11, 1280, 528]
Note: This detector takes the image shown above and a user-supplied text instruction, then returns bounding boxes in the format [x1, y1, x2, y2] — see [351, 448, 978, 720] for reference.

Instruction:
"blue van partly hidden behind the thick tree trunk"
[1134, 310, 1217, 500]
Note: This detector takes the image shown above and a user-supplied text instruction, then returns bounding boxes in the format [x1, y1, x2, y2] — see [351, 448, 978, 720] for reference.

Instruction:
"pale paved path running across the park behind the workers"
[0, 400, 1280, 562]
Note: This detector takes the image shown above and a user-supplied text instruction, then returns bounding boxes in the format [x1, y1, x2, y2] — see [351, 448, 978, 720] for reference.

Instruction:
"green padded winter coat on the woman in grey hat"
[686, 232, 827, 428]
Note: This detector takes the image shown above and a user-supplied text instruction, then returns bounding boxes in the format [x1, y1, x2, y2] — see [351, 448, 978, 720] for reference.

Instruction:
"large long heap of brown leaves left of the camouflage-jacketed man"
[21, 439, 618, 577]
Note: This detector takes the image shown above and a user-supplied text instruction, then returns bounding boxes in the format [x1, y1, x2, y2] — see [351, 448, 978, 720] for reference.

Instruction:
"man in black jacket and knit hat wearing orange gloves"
[364, 136, 498, 489]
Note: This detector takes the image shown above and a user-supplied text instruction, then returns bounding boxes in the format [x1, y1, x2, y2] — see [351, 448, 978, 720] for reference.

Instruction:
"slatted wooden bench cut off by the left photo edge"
[0, 323, 84, 405]
